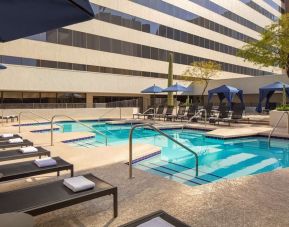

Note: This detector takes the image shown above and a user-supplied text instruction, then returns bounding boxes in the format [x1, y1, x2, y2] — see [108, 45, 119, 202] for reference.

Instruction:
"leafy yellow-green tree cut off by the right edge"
[238, 13, 289, 77]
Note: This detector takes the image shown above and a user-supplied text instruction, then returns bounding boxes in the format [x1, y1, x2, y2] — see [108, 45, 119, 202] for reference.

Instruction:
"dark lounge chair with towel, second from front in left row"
[0, 157, 73, 182]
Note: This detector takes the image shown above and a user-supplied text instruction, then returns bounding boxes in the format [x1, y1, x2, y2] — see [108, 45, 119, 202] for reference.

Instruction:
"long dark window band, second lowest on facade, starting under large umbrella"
[26, 28, 272, 76]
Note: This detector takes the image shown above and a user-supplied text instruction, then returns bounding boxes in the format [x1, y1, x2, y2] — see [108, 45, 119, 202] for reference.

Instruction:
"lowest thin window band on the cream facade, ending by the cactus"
[0, 55, 182, 80]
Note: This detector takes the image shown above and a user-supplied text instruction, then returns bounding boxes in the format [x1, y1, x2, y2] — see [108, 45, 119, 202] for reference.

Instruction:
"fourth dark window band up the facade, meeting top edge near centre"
[131, 0, 256, 43]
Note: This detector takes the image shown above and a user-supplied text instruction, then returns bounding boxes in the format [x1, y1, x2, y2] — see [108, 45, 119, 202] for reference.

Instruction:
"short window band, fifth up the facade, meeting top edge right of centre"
[190, 0, 264, 33]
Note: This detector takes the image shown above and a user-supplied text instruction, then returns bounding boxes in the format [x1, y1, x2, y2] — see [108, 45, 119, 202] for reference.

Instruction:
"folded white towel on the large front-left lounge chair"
[63, 176, 95, 192]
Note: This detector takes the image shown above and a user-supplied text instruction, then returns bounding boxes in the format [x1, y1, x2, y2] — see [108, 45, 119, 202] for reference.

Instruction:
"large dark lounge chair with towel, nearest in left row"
[0, 174, 117, 217]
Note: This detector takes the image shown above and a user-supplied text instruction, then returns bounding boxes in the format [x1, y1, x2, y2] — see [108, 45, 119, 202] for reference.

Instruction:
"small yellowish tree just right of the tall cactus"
[182, 61, 221, 104]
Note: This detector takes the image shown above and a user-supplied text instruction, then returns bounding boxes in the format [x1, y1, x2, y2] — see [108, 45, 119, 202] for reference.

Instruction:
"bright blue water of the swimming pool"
[35, 122, 289, 186]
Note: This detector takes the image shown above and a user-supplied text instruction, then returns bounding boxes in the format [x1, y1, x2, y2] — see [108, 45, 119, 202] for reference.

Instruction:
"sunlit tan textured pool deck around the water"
[0, 118, 289, 227]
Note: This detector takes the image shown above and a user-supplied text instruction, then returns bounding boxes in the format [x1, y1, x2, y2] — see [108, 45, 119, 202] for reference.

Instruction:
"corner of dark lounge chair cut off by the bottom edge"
[119, 210, 189, 227]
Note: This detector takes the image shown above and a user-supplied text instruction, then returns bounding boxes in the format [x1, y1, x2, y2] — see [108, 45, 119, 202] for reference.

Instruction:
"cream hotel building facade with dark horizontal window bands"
[0, 0, 286, 105]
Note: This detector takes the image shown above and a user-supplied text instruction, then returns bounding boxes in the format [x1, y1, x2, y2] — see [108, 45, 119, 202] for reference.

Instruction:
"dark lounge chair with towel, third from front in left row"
[0, 147, 50, 162]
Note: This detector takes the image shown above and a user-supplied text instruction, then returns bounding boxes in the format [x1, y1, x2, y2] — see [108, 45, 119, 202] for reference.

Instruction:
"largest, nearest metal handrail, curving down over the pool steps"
[129, 123, 199, 179]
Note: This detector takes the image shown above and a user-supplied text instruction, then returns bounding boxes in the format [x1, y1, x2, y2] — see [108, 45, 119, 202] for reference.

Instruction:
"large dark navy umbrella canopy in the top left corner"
[0, 0, 95, 42]
